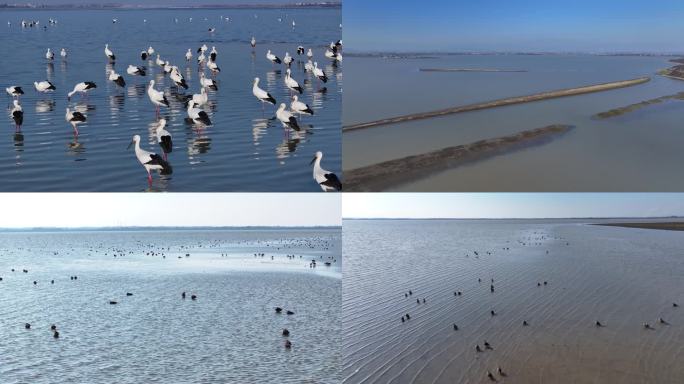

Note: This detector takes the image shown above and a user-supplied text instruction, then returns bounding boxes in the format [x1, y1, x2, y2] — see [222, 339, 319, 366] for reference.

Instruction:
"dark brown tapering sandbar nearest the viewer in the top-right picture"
[344, 125, 572, 192]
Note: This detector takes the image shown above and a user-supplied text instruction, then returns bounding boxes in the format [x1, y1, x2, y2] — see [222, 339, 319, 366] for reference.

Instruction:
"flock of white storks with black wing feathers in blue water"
[5, 15, 342, 192]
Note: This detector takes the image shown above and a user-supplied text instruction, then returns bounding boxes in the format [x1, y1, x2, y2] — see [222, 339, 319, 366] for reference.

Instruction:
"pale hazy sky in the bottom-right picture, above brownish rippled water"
[342, 193, 684, 218]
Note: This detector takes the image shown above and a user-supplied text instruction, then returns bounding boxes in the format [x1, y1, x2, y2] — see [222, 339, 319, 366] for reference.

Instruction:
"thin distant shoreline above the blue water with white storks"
[0, 2, 342, 11]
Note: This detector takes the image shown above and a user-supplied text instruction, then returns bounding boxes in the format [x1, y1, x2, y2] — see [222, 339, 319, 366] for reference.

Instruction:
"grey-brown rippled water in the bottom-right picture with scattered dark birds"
[342, 220, 684, 383]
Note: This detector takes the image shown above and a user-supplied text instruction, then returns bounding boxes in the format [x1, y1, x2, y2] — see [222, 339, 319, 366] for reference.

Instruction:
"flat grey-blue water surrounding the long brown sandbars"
[343, 55, 684, 191]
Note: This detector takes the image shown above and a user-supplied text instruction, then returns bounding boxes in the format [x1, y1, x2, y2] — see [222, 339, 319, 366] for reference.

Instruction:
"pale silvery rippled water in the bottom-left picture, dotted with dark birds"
[0, 228, 342, 383]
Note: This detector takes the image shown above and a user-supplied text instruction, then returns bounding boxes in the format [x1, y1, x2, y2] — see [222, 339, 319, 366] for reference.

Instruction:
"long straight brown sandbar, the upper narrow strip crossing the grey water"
[342, 77, 651, 132]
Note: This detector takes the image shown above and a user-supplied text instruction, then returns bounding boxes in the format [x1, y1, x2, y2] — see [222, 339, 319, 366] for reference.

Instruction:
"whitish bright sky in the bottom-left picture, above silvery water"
[0, 193, 342, 228]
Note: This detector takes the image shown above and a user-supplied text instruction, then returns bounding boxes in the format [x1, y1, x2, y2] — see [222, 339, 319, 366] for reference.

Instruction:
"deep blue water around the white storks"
[0, 9, 342, 191]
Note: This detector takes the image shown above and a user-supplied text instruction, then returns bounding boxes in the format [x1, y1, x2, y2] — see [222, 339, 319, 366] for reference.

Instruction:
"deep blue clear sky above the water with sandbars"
[342, 0, 684, 52]
